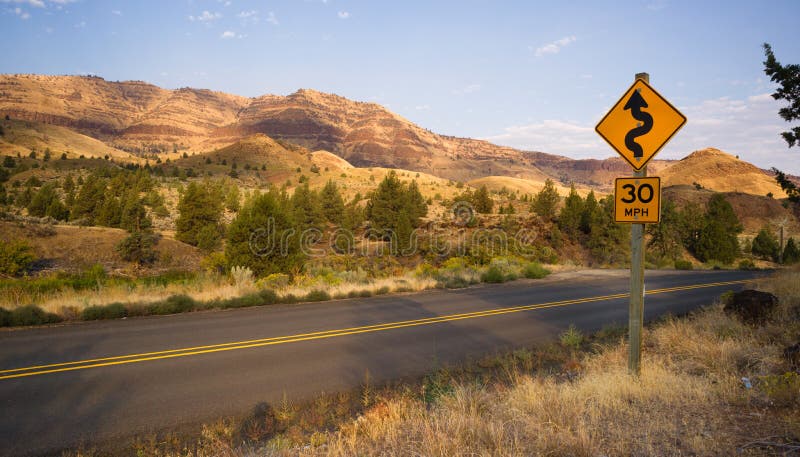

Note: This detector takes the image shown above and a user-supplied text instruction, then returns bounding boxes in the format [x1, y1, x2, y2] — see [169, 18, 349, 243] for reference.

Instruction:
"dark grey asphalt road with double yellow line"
[0, 271, 756, 455]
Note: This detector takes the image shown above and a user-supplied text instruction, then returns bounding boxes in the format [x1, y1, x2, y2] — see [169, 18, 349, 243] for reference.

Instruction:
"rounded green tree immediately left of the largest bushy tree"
[175, 182, 222, 246]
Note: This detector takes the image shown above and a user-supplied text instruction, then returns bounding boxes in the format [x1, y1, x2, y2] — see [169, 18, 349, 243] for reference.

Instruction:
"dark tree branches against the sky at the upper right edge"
[764, 43, 800, 147]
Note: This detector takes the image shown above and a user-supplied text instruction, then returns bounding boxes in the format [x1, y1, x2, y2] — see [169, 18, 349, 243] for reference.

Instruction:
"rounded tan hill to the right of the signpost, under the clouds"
[661, 148, 786, 198]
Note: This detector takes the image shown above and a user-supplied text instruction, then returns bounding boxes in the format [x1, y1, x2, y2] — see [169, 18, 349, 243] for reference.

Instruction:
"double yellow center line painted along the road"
[0, 280, 749, 380]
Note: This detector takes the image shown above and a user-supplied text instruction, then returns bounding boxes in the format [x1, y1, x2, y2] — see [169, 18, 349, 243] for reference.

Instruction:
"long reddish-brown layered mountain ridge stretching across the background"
[0, 75, 783, 197]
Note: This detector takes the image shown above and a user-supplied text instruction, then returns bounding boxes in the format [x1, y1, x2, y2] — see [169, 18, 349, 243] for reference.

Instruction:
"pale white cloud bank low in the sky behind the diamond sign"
[485, 93, 800, 174]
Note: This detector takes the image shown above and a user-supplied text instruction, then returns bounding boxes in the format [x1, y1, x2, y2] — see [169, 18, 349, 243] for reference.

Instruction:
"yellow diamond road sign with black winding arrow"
[595, 79, 686, 170]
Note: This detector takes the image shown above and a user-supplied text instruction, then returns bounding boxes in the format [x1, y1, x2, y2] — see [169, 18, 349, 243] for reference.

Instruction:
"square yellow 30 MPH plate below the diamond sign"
[614, 177, 661, 224]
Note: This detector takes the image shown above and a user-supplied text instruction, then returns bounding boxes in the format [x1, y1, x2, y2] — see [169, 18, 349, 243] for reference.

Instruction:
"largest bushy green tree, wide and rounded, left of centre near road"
[225, 190, 305, 276]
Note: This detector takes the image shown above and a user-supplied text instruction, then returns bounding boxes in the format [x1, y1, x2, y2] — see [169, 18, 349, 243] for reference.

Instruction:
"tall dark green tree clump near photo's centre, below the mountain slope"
[366, 171, 428, 240]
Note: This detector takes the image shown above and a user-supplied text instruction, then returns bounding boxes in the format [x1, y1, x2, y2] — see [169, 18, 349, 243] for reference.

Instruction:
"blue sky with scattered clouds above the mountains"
[0, 0, 800, 174]
